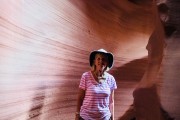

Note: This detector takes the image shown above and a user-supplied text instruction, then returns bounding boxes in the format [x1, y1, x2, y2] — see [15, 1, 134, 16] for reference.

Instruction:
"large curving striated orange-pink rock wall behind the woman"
[0, 0, 173, 120]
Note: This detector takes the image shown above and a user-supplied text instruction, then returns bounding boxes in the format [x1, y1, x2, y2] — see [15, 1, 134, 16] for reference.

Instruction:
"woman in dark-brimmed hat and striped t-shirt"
[76, 49, 117, 120]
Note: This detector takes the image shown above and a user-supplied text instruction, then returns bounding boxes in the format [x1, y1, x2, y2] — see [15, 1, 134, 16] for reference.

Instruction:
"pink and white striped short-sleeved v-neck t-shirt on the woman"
[79, 71, 117, 120]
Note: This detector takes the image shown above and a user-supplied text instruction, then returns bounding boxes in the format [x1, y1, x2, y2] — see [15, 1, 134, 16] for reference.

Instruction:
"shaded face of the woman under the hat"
[94, 53, 108, 71]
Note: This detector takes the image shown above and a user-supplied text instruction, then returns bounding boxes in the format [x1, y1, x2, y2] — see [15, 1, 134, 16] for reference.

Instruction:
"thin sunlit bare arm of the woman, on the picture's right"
[109, 90, 114, 120]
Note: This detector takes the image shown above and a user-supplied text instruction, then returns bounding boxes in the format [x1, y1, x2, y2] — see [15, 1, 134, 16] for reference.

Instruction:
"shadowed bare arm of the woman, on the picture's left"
[75, 88, 85, 120]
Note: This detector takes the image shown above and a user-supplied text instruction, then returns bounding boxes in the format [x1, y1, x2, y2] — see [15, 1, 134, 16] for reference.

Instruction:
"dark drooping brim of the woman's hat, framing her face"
[89, 51, 114, 68]
